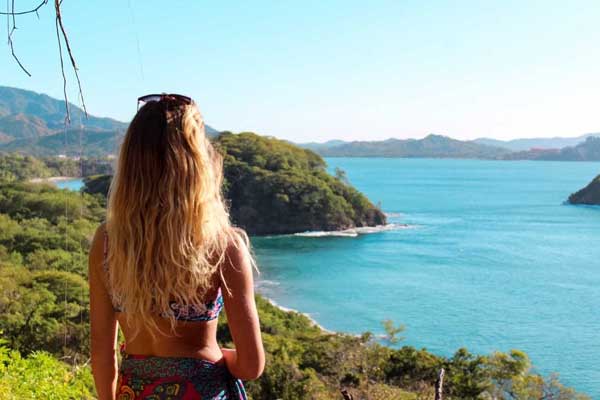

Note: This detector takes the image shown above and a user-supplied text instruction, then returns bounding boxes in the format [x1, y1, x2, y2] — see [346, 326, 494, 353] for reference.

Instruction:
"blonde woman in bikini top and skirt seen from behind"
[89, 94, 264, 400]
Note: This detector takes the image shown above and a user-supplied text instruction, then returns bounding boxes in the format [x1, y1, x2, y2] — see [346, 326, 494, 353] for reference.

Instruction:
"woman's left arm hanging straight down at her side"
[89, 226, 117, 400]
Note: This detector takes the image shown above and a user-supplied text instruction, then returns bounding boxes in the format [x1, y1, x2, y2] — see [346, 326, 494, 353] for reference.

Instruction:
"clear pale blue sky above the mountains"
[0, 0, 600, 141]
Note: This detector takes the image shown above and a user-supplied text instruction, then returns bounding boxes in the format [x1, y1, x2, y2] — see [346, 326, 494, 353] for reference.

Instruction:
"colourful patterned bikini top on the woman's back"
[103, 230, 223, 322]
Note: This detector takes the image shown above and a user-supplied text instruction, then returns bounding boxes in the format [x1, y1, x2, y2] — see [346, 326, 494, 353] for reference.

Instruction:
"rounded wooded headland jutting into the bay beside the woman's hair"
[215, 132, 385, 234]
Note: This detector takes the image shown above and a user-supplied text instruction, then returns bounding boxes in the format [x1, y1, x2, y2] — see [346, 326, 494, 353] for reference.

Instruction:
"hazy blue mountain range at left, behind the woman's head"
[0, 86, 219, 156]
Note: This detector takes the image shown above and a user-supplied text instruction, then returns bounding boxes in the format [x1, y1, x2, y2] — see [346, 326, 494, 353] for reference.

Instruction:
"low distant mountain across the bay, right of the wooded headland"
[301, 135, 510, 159]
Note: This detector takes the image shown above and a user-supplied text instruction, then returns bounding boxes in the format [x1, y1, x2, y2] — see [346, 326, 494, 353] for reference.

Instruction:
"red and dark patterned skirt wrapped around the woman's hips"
[117, 352, 247, 400]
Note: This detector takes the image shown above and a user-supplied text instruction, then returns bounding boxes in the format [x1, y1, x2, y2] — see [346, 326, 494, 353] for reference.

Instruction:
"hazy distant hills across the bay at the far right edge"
[504, 136, 600, 161]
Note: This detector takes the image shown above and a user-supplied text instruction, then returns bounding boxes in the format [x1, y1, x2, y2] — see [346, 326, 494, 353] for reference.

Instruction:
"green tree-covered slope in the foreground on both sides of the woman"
[0, 152, 586, 400]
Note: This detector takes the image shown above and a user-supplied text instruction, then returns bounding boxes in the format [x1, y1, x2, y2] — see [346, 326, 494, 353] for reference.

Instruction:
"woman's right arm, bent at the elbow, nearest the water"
[223, 234, 265, 380]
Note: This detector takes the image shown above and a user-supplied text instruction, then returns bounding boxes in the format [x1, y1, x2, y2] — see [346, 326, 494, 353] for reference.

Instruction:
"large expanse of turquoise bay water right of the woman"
[252, 158, 600, 399]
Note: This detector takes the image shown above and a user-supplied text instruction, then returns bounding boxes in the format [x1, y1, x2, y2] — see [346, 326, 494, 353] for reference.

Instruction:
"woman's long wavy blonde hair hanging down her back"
[107, 101, 248, 334]
